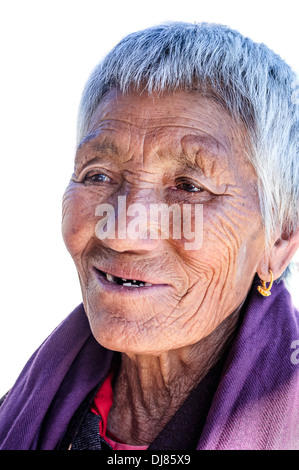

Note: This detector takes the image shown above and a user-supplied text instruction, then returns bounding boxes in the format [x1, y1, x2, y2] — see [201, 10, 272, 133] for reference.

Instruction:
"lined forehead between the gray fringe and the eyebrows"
[77, 90, 248, 171]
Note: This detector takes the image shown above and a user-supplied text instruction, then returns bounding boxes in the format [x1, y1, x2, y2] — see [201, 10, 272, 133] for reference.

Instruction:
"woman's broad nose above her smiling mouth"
[95, 196, 161, 253]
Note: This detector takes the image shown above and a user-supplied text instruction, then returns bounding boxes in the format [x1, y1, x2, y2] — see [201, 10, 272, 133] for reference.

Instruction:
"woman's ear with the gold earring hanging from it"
[257, 228, 299, 282]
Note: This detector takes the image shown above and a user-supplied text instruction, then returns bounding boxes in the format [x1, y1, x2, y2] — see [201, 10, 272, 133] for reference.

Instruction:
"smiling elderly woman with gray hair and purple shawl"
[0, 23, 299, 450]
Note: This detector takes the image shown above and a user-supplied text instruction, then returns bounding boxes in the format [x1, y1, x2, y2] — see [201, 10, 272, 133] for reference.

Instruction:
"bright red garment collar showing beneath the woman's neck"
[91, 371, 148, 450]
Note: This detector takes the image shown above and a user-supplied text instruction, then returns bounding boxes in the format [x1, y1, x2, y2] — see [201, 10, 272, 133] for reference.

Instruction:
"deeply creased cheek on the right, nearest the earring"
[185, 201, 263, 295]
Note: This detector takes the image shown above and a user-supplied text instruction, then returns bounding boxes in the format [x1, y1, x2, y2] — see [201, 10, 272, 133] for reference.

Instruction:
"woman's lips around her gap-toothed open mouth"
[93, 266, 169, 295]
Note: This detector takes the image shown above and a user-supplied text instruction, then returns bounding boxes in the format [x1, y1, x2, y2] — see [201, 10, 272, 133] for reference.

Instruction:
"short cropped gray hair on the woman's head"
[78, 22, 299, 262]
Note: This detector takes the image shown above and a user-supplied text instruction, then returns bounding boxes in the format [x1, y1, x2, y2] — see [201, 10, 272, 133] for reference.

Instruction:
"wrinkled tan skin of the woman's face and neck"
[63, 90, 267, 444]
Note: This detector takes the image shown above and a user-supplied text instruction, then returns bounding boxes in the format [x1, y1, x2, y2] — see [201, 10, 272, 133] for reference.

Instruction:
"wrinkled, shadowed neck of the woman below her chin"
[108, 309, 240, 445]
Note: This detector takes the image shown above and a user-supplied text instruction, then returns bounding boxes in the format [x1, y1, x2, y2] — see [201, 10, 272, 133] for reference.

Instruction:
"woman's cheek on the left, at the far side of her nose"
[62, 183, 97, 259]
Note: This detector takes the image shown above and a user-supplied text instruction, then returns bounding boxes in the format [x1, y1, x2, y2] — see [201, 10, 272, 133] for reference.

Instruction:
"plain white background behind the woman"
[0, 0, 299, 395]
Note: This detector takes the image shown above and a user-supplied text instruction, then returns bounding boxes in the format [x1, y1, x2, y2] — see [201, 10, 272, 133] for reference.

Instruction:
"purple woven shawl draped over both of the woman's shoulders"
[0, 283, 299, 450]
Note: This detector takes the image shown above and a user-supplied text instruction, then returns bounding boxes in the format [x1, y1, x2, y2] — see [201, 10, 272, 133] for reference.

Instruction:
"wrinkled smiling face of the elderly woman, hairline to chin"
[63, 90, 264, 354]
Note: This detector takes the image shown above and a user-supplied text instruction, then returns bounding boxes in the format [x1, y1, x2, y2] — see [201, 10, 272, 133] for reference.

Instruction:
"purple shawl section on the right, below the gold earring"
[197, 283, 299, 450]
